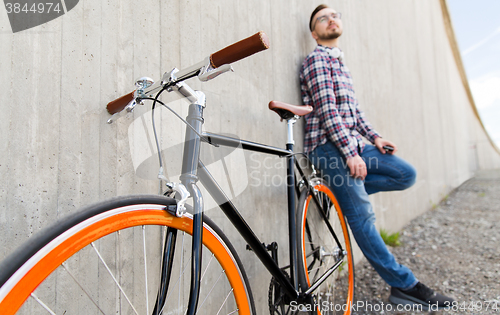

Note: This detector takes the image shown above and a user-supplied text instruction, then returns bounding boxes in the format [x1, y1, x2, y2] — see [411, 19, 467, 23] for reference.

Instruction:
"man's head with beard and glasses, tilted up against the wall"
[309, 4, 343, 43]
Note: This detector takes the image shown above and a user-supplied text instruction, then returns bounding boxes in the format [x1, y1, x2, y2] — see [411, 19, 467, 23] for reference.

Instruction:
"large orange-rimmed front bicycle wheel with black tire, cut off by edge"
[0, 195, 255, 314]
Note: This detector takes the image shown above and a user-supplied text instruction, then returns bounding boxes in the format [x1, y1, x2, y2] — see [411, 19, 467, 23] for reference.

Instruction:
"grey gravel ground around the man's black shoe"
[355, 170, 500, 314]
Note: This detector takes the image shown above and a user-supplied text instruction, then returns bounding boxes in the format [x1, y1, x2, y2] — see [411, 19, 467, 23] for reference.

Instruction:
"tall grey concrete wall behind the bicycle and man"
[0, 0, 500, 313]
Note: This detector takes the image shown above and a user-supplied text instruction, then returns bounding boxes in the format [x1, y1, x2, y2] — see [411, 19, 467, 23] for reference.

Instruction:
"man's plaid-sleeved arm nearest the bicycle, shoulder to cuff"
[303, 55, 358, 159]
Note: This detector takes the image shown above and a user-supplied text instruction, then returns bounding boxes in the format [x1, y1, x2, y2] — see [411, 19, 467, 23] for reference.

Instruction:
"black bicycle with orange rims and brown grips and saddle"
[0, 32, 354, 314]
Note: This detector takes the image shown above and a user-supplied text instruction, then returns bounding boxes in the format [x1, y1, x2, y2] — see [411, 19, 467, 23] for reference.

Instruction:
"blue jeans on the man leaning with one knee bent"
[309, 141, 418, 290]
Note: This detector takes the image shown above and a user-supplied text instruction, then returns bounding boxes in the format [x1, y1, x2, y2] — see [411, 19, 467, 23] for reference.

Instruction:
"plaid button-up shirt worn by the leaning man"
[300, 45, 380, 159]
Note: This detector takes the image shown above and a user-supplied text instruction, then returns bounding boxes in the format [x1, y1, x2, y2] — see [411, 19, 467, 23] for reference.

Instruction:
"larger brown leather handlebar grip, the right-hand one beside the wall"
[210, 32, 269, 68]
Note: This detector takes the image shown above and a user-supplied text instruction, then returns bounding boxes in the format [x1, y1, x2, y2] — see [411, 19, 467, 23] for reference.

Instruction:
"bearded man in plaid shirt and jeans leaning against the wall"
[300, 5, 453, 308]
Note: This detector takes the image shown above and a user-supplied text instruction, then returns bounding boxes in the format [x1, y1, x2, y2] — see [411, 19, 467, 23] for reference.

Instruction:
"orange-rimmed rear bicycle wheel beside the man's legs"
[297, 178, 354, 315]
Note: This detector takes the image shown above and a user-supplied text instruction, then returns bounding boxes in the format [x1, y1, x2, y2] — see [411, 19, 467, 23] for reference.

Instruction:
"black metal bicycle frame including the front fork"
[163, 103, 343, 314]
